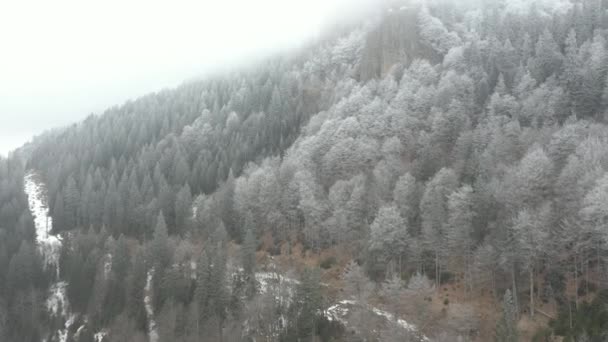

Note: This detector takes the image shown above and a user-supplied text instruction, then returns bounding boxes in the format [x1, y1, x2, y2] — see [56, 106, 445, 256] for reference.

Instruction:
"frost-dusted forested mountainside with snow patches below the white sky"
[0, 0, 608, 342]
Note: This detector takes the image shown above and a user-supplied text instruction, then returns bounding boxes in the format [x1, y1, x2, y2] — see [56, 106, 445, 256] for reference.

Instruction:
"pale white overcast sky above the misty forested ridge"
[0, 0, 378, 154]
